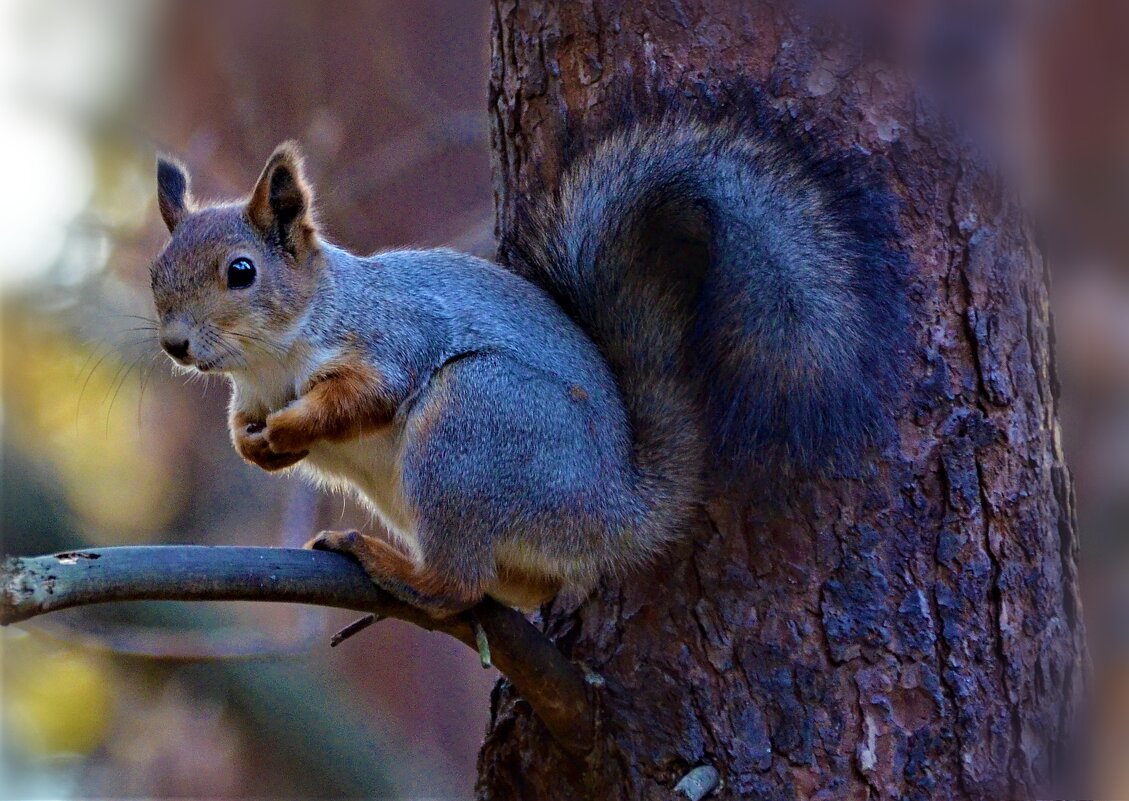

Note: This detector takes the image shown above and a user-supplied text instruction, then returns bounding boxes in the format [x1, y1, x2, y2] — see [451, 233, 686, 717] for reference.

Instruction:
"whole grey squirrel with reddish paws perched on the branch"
[151, 113, 904, 618]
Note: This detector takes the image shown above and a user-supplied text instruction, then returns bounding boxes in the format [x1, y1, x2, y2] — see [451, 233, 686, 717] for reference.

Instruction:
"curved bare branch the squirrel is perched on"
[0, 546, 595, 756]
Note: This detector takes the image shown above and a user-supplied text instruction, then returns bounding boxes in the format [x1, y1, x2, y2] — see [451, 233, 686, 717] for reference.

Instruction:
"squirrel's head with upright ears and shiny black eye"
[150, 142, 323, 372]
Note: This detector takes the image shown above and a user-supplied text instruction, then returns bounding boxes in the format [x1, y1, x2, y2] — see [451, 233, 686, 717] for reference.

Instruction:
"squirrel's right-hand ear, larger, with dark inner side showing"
[247, 141, 316, 253]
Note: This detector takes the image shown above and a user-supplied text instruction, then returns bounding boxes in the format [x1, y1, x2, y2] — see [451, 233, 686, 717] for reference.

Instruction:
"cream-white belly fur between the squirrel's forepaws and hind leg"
[299, 426, 420, 560]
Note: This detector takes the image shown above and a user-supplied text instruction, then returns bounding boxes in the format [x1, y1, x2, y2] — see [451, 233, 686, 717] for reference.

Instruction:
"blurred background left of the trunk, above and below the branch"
[0, 0, 497, 800]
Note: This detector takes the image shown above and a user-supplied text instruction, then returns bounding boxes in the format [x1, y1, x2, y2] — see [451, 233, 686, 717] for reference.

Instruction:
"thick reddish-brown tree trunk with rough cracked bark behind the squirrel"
[479, 0, 1085, 799]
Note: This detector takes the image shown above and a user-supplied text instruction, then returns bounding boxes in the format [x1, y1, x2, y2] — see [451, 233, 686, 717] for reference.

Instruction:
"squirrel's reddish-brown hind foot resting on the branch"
[306, 531, 485, 619]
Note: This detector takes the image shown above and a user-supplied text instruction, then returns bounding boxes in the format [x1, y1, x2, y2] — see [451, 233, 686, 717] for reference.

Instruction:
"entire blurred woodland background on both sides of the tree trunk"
[0, 0, 1129, 799]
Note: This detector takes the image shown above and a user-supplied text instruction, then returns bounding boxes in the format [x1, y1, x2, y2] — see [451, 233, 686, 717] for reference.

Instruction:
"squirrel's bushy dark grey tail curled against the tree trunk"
[504, 114, 904, 499]
